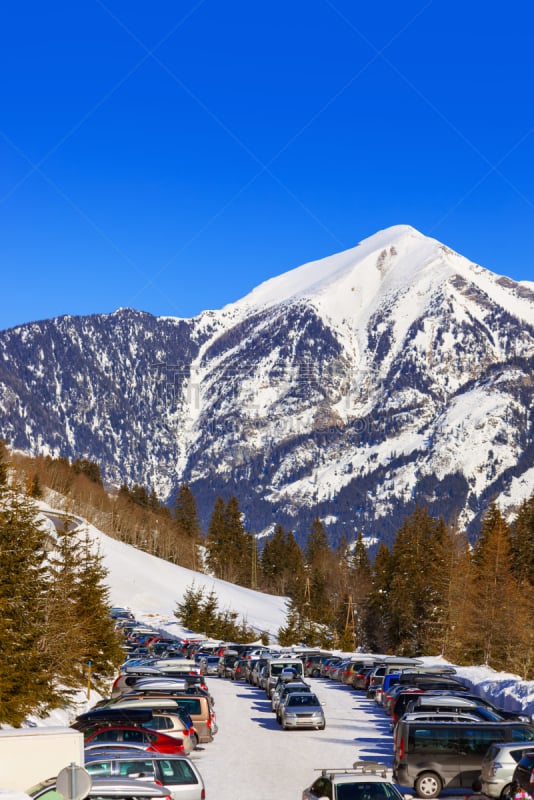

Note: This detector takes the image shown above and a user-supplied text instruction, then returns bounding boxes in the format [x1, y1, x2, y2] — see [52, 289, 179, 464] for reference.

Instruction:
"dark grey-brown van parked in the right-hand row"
[393, 719, 534, 798]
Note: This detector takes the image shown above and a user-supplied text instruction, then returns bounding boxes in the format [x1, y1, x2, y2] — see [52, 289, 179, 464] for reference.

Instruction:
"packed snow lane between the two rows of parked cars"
[193, 678, 393, 800]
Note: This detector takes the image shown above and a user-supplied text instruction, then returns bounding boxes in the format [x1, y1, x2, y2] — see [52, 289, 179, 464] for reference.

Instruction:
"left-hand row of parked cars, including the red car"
[27, 608, 217, 800]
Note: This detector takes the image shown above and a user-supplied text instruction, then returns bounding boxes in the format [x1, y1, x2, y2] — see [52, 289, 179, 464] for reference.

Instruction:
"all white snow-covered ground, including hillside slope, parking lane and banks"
[0, 503, 534, 800]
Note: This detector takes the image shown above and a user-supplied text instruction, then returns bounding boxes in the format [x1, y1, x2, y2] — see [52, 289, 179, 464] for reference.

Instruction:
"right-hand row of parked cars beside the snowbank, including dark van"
[308, 655, 534, 800]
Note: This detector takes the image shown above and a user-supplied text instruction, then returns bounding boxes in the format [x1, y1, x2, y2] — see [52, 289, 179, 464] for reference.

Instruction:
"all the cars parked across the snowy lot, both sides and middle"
[30, 615, 534, 800]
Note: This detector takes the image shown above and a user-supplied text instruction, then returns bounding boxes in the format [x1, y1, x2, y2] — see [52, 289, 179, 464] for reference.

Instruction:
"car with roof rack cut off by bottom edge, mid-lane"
[302, 761, 403, 800]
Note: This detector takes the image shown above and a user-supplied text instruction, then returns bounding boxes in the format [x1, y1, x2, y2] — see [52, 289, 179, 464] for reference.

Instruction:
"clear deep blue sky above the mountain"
[0, 0, 534, 328]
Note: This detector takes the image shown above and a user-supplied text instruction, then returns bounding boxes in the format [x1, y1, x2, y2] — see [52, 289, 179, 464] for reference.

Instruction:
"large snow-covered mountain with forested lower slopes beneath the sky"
[0, 226, 534, 552]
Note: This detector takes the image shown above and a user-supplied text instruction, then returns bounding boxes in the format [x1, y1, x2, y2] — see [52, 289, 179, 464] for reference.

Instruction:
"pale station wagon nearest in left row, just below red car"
[85, 753, 205, 800]
